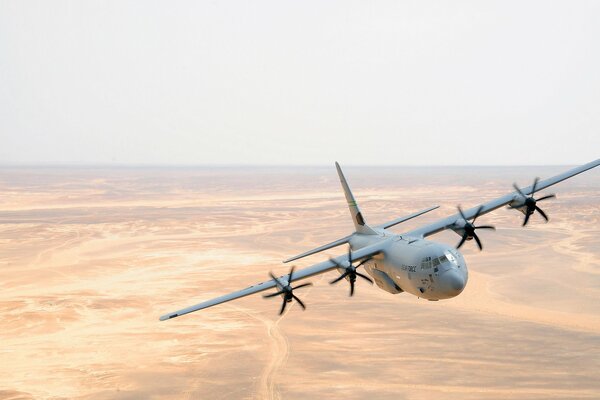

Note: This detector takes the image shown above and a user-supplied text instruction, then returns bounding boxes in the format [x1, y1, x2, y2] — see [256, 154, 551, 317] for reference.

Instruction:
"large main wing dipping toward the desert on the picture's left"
[160, 240, 388, 321]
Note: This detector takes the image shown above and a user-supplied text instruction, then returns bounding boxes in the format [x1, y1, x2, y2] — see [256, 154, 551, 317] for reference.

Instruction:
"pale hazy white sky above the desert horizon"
[0, 0, 600, 165]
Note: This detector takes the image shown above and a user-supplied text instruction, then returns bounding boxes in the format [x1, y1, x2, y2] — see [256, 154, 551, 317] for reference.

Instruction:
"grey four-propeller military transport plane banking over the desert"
[160, 159, 600, 321]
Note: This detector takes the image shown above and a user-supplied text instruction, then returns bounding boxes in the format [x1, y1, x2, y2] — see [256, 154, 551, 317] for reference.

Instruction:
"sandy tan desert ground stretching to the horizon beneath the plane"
[0, 166, 600, 400]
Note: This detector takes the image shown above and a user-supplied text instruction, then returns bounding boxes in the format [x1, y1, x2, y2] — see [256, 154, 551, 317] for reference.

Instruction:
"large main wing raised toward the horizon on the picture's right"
[403, 159, 600, 241]
